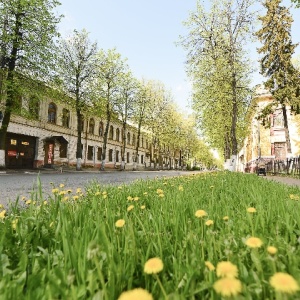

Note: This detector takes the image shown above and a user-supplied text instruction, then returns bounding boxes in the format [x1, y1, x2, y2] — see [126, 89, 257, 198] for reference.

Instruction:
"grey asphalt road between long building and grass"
[0, 171, 192, 207]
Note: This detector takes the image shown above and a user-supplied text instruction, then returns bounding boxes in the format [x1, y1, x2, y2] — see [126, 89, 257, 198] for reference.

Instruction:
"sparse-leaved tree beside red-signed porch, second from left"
[57, 30, 97, 171]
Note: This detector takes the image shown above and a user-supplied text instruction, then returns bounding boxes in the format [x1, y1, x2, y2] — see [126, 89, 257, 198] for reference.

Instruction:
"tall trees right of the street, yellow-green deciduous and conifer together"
[182, 0, 300, 166]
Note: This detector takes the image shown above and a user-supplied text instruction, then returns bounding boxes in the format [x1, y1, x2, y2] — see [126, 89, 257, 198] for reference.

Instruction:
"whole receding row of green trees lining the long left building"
[0, 0, 218, 170]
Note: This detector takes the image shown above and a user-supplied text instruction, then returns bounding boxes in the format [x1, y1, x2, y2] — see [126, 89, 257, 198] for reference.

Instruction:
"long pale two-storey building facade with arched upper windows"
[0, 98, 185, 169]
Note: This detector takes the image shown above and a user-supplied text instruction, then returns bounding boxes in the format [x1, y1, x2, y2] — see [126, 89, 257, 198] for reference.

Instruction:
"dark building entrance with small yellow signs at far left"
[5, 133, 36, 169]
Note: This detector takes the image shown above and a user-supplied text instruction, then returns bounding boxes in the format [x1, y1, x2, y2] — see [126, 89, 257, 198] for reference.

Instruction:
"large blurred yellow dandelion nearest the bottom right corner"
[270, 272, 299, 294]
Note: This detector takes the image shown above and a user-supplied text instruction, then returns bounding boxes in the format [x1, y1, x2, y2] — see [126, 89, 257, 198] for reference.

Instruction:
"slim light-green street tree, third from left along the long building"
[92, 49, 128, 171]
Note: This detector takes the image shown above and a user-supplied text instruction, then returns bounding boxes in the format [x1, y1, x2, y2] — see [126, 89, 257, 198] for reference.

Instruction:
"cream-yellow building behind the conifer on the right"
[237, 86, 300, 172]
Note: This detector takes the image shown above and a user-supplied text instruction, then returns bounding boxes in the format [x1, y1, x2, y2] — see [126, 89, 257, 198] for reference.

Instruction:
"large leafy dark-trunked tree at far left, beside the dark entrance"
[0, 0, 60, 167]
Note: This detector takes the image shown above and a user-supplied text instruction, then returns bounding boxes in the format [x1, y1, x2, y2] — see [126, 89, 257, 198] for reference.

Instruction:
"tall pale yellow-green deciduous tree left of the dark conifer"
[182, 0, 254, 169]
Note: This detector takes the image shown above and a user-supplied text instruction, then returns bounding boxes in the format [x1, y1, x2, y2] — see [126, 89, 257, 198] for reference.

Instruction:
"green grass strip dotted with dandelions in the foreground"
[0, 172, 300, 300]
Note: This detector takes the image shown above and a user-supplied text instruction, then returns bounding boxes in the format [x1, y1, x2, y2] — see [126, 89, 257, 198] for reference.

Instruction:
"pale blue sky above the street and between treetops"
[57, 0, 300, 112]
